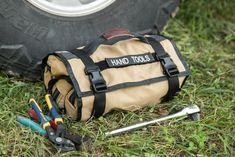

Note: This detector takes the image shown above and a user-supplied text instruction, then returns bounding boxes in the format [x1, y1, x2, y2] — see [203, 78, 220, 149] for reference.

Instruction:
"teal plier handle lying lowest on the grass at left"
[16, 115, 47, 136]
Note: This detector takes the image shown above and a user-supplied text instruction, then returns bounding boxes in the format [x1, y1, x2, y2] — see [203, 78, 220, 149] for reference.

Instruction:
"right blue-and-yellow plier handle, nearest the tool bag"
[45, 94, 63, 124]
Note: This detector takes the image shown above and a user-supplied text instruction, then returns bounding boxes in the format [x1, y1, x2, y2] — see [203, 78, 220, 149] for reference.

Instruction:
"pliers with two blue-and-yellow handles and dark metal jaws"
[30, 94, 82, 152]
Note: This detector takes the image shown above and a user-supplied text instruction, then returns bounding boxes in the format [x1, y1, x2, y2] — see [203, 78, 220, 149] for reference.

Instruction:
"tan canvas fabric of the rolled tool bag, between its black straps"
[43, 33, 189, 121]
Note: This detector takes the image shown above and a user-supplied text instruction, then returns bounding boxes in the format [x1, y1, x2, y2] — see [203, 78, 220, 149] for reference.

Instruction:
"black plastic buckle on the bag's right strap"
[160, 57, 179, 77]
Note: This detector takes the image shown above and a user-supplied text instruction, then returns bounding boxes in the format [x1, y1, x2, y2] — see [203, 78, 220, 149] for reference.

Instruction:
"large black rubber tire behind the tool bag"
[0, 0, 179, 80]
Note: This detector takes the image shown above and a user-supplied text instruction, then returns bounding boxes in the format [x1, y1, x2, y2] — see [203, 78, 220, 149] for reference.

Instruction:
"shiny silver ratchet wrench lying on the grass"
[105, 105, 200, 136]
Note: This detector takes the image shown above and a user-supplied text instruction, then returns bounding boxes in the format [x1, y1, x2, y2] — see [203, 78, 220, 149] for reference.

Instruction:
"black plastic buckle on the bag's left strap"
[85, 66, 107, 93]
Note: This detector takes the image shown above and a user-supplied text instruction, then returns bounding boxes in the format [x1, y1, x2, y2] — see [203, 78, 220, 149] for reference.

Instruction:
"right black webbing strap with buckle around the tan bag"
[147, 37, 180, 101]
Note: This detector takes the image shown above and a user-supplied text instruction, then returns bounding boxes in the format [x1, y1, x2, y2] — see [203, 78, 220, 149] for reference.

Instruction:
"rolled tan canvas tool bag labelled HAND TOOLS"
[43, 29, 189, 121]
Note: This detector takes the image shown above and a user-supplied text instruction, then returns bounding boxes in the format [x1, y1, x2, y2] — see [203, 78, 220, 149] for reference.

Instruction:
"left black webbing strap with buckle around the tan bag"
[70, 49, 107, 118]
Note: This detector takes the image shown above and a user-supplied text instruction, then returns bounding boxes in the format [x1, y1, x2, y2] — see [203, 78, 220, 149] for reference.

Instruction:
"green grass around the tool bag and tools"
[0, 0, 235, 157]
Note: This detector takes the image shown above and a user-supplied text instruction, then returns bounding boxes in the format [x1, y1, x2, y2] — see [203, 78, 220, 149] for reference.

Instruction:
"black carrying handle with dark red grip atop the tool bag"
[83, 28, 148, 55]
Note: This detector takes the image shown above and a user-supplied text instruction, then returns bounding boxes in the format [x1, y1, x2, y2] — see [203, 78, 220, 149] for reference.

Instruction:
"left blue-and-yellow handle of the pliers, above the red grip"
[29, 99, 51, 129]
